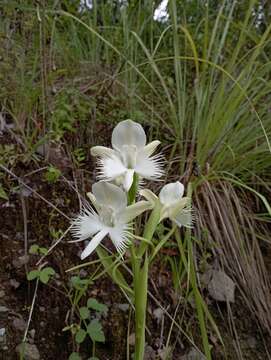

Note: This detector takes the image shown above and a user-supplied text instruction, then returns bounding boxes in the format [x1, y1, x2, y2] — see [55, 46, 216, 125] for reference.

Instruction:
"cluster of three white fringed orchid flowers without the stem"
[72, 120, 192, 260]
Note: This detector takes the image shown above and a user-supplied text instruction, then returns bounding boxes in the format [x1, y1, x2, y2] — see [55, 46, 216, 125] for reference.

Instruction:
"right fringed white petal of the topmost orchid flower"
[135, 150, 164, 180]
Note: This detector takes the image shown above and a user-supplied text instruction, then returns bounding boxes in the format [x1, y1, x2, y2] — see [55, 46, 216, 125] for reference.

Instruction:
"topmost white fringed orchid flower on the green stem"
[91, 120, 163, 191]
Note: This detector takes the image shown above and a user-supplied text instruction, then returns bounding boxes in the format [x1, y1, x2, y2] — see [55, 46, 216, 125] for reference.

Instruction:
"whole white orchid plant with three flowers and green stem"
[72, 120, 192, 360]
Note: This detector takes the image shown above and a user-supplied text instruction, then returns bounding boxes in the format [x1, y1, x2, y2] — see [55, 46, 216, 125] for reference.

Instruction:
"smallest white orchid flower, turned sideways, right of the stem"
[140, 181, 193, 227]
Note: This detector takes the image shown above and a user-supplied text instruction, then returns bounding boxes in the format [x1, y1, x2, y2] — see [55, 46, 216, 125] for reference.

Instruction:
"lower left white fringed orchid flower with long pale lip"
[71, 181, 151, 260]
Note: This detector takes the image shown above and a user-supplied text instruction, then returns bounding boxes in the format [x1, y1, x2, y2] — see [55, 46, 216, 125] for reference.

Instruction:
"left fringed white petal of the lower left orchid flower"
[71, 208, 103, 241]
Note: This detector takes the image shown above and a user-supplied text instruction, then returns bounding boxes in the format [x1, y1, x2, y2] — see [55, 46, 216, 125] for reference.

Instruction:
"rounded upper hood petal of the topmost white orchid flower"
[112, 120, 146, 151]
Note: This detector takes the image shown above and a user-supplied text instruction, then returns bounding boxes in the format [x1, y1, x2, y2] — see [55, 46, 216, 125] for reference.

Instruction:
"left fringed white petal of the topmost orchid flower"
[98, 156, 127, 180]
